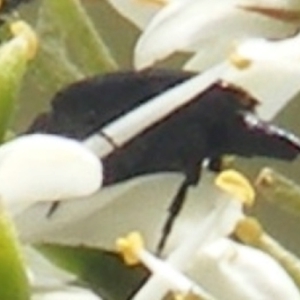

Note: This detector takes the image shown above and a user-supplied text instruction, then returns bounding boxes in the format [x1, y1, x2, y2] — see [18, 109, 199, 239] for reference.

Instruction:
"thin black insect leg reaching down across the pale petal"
[156, 179, 191, 256]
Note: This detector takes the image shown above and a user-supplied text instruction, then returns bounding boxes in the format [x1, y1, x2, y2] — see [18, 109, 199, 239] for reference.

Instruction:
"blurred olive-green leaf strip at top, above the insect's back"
[39, 0, 117, 74]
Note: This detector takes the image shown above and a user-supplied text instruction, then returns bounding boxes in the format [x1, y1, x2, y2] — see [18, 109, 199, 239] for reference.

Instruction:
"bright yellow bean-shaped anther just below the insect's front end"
[215, 170, 255, 206]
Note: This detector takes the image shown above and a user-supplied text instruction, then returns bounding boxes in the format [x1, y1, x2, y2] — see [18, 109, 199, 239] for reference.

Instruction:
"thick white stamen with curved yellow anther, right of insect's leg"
[130, 170, 250, 300]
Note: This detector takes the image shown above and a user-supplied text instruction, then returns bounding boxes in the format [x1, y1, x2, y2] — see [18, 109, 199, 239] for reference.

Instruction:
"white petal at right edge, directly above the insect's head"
[222, 36, 300, 120]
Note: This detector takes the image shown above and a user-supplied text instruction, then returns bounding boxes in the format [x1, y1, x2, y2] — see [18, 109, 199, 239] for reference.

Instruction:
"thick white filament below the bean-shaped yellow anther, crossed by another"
[134, 195, 242, 300]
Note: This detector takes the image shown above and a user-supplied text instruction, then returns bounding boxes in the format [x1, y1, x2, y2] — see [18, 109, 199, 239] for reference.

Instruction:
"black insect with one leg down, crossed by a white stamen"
[28, 70, 300, 252]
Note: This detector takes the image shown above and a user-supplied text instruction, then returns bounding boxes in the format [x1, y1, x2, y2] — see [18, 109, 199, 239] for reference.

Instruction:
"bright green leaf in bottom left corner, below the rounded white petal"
[0, 203, 29, 300]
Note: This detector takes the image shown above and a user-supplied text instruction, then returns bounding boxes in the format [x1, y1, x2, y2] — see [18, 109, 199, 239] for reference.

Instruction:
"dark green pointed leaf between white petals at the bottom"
[38, 244, 148, 300]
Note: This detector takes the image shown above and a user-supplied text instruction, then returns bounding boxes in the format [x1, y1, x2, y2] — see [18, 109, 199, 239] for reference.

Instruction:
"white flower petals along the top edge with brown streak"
[105, 0, 300, 69]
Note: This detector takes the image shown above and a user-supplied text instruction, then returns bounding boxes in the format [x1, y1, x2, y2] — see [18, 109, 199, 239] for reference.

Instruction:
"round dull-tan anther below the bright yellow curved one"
[235, 217, 263, 245]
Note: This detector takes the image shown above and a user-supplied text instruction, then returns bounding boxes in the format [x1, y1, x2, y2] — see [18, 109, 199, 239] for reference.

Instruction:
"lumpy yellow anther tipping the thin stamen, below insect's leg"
[116, 231, 144, 266]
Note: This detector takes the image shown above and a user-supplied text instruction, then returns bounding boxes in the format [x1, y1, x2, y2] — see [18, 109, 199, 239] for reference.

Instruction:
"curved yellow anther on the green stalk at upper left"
[10, 21, 39, 59]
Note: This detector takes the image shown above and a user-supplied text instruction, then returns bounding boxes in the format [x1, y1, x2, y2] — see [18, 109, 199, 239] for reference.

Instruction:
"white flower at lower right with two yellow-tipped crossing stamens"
[117, 171, 300, 300]
